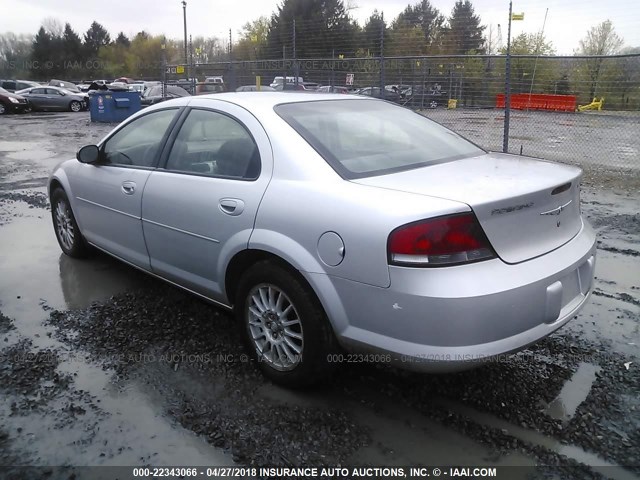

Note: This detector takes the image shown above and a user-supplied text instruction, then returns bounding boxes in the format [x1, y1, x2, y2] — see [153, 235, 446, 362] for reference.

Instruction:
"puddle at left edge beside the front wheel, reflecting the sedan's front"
[0, 210, 141, 338]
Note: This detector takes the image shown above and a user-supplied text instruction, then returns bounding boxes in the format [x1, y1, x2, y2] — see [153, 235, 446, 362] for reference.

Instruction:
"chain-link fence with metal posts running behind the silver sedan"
[165, 48, 640, 171]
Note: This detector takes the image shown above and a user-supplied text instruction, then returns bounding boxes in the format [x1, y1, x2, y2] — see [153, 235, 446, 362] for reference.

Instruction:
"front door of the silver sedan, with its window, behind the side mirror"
[72, 108, 179, 269]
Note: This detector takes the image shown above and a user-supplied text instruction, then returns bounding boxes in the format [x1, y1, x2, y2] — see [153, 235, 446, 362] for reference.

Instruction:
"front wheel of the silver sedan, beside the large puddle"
[51, 188, 90, 258]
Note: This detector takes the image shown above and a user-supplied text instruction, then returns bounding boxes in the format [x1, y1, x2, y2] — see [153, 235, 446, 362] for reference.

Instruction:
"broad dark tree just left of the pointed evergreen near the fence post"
[392, 0, 444, 54]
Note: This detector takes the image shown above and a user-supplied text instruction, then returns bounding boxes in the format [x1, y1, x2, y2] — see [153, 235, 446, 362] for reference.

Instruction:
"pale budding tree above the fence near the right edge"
[577, 20, 623, 99]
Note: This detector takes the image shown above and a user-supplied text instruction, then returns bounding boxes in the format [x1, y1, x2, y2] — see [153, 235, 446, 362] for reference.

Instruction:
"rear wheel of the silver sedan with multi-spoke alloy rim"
[235, 260, 337, 388]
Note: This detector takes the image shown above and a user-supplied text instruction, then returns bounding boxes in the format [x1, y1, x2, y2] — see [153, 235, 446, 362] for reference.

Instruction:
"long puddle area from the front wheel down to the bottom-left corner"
[0, 207, 233, 465]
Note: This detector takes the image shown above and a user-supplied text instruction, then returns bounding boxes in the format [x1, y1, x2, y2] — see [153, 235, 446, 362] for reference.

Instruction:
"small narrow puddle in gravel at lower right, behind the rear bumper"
[545, 362, 602, 424]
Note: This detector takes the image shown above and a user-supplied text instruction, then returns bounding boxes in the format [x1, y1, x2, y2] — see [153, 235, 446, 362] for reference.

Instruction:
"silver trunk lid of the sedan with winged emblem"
[353, 153, 582, 263]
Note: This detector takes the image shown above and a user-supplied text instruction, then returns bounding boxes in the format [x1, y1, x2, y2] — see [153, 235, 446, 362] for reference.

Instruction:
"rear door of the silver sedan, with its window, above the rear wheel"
[142, 100, 273, 302]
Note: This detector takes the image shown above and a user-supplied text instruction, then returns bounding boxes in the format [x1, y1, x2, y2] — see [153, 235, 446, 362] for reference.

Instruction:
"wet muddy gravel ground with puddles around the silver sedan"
[0, 113, 640, 479]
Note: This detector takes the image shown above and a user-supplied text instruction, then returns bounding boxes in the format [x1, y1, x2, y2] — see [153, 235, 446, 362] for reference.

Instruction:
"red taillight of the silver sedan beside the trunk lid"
[387, 213, 495, 267]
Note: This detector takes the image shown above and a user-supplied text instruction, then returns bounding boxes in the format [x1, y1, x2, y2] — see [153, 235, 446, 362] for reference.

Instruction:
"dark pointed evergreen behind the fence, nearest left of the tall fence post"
[442, 0, 485, 55]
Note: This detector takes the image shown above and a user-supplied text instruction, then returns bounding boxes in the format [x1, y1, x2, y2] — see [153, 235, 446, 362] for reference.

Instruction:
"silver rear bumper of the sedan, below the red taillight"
[321, 219, 596, 371]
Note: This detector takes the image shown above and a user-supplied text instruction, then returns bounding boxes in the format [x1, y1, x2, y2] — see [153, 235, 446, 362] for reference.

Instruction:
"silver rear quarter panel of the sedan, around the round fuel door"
[250, 114, 469, 287]
